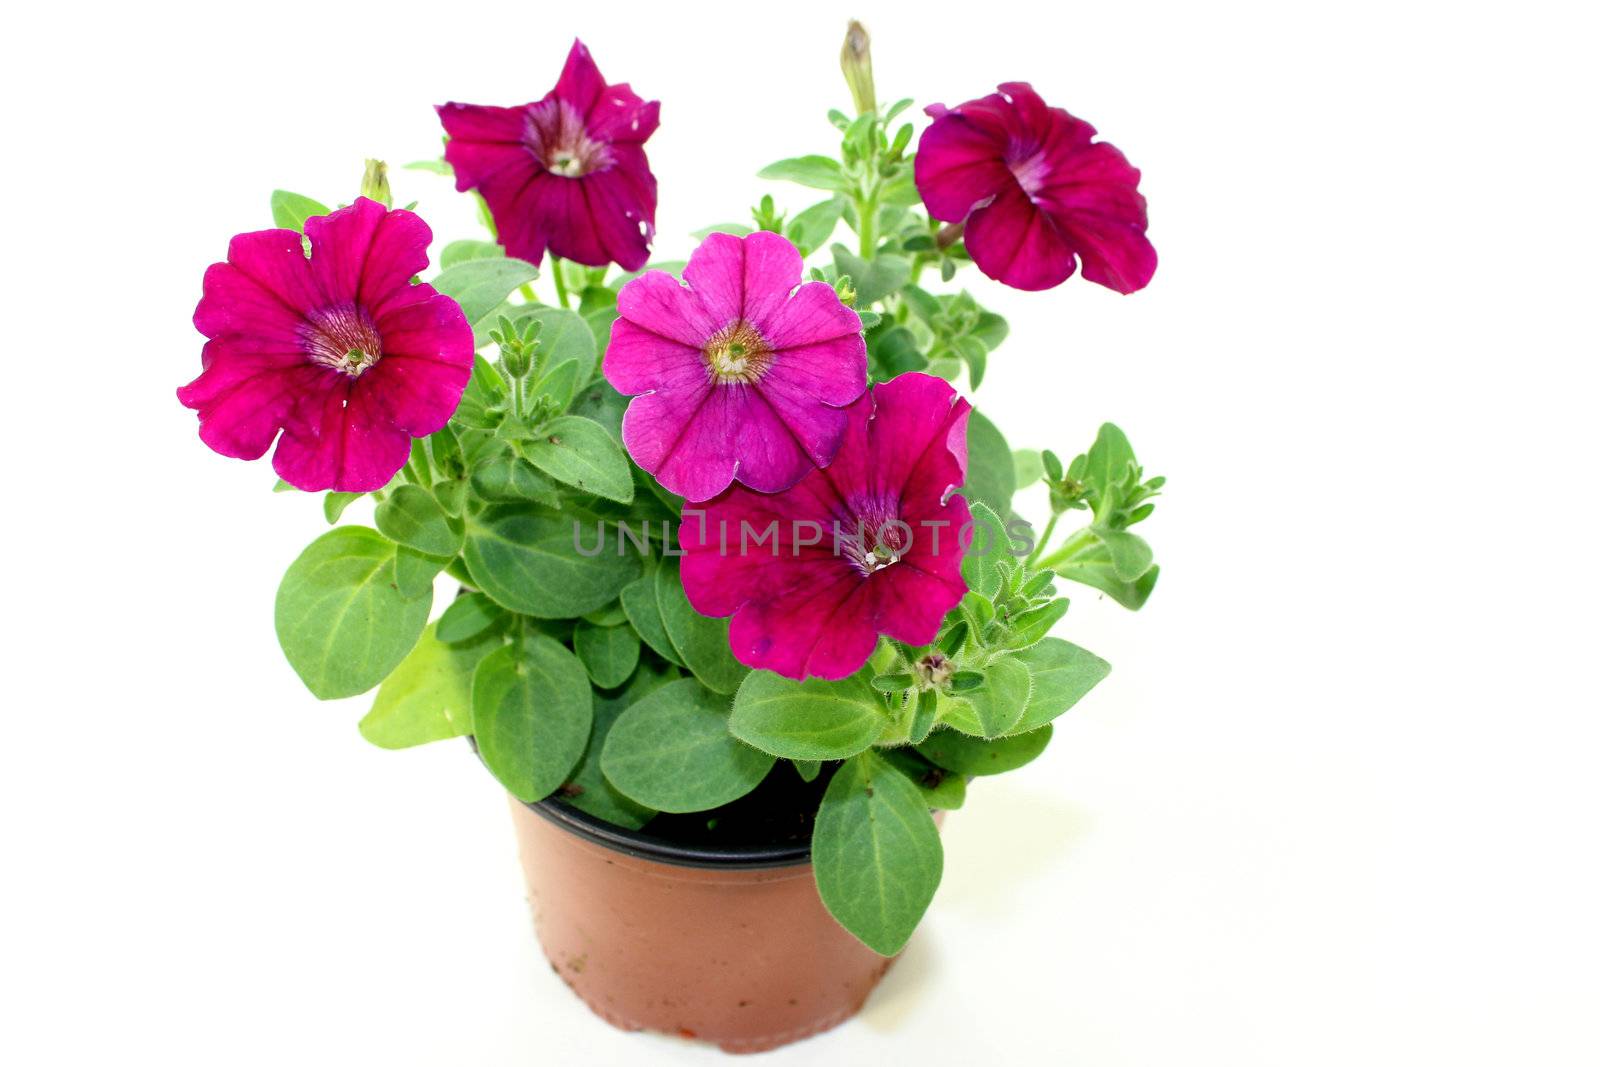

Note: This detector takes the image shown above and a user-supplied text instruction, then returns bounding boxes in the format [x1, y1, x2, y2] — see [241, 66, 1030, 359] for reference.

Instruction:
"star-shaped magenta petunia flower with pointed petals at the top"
[438, 42, 661, 270]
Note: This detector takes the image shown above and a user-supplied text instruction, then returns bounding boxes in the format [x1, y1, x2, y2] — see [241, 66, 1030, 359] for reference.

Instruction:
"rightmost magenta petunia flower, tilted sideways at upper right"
[917, 82, 1155, 293]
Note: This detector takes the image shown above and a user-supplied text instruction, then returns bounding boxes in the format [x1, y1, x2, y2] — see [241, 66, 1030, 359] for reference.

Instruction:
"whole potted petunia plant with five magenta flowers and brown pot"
[178, 24, 1162, 1051]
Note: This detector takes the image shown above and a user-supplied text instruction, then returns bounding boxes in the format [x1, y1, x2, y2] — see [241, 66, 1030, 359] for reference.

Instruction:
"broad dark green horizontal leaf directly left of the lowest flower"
[464, 507, 642, 619]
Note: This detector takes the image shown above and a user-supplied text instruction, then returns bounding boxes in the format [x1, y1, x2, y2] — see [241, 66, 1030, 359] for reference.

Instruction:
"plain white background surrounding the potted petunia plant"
[0, 0, 1600, 1067]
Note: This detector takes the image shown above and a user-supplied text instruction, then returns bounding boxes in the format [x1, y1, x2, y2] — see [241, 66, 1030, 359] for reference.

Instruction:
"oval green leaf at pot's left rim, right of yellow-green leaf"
[472, 633, 594, 803]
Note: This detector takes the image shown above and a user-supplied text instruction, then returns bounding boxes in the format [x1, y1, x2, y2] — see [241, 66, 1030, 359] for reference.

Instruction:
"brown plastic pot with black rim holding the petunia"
[512, 800, 893, 1053]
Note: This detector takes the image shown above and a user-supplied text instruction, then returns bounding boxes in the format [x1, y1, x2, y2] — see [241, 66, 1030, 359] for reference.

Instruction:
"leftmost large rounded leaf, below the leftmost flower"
[275, 526, 434, 701]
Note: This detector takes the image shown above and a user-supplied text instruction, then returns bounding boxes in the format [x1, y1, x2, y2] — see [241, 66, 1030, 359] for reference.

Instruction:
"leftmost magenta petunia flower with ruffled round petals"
[178, 197, 472, 493]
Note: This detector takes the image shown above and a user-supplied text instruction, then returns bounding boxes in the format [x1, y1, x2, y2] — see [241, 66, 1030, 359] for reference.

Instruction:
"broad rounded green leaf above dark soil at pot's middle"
[600, 678, 773, 811]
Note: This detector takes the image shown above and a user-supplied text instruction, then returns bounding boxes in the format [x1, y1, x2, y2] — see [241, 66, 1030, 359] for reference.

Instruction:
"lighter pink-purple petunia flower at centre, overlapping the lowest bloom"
[605, 232, 867, 501]
